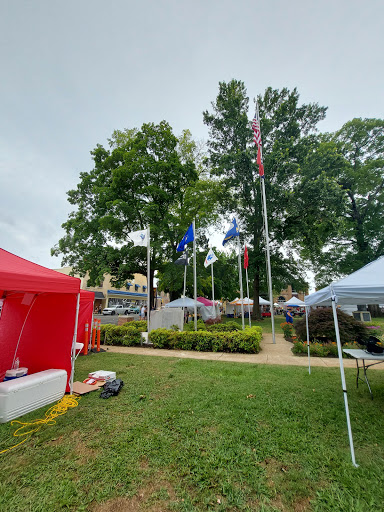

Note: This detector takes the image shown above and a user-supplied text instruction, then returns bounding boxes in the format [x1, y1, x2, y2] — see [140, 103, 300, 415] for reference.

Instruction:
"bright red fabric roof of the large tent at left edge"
[0, 249, 80, 293]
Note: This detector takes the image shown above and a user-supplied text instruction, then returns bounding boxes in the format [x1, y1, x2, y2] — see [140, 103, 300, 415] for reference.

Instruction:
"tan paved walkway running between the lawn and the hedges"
[104, 333, 384, 370]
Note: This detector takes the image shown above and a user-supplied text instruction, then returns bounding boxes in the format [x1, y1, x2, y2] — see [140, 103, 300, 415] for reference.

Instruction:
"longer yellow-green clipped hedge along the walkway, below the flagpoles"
[149, 327, 262, 354]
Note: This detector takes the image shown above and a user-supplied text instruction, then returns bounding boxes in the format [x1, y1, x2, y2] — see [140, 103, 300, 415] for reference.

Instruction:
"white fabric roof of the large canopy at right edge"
[305, 256, 384, 306]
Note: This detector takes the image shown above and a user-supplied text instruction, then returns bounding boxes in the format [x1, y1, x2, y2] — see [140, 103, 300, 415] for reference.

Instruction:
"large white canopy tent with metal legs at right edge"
[305, 256, 384, 466]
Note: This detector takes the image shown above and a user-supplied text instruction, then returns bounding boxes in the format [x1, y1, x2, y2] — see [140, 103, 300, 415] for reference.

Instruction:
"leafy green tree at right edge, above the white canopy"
[299, 119, 384, 285]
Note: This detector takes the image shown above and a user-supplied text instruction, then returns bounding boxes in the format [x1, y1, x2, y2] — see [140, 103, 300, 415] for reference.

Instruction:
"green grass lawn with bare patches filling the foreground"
[0, 353, 384, 512]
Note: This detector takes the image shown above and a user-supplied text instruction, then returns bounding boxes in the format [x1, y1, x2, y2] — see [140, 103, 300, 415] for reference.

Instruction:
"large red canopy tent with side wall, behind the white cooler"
[0, 249, 80, 390]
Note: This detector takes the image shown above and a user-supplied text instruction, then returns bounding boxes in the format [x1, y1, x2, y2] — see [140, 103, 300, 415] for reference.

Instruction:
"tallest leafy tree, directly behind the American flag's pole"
[203, 80, 326, 317]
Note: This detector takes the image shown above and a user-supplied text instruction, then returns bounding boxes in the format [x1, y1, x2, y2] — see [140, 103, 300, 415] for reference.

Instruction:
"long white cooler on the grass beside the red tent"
[0, 370, 68, 423]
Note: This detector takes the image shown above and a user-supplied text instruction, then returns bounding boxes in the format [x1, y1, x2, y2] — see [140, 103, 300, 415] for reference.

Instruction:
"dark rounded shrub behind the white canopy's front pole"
[295, 308, 370, 344]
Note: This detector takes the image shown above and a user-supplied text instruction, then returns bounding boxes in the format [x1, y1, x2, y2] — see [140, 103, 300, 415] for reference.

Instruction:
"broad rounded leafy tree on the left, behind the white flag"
[52, 121, 216, 306]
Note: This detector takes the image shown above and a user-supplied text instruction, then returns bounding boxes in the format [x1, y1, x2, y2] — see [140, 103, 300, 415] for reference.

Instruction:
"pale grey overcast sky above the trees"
[0, 0, 384, 276]
